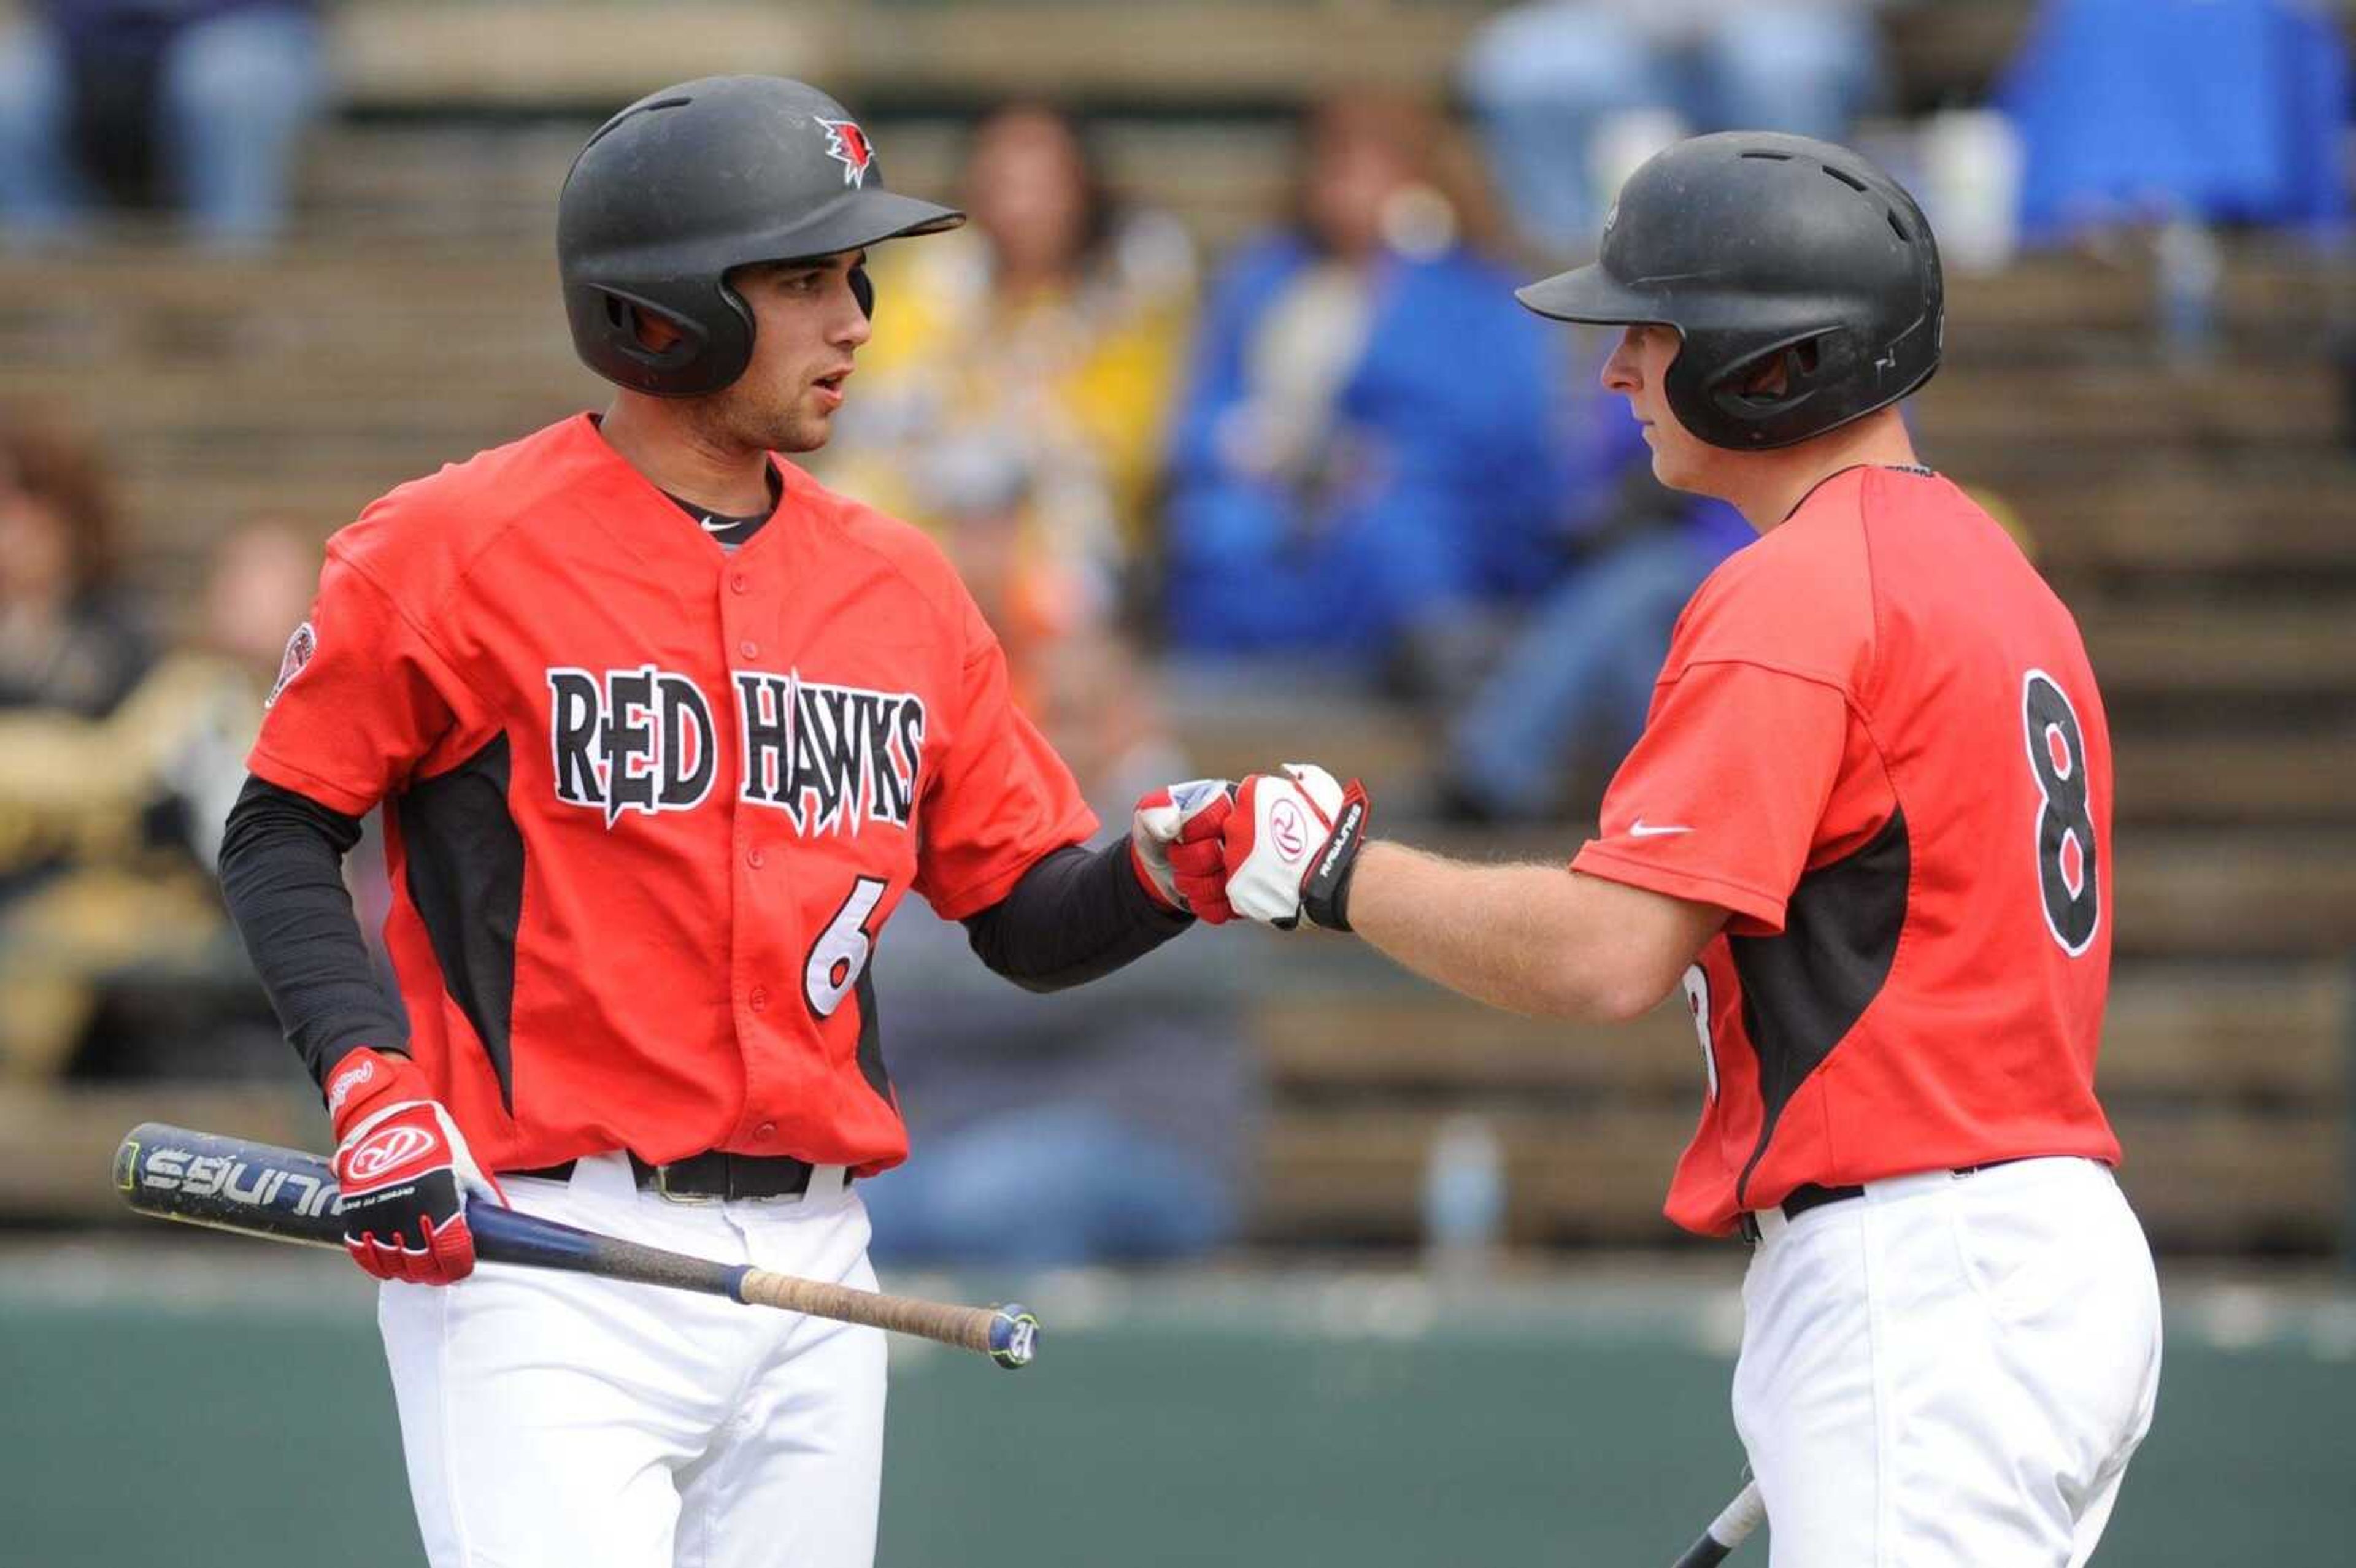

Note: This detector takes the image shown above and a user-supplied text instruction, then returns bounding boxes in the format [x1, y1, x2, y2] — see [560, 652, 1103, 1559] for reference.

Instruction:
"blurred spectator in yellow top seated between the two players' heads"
[820, 104, 1195, 666]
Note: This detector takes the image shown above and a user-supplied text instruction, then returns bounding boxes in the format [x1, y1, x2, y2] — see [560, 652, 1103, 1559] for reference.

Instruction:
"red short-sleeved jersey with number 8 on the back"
[1574, 469, 2118, 1234]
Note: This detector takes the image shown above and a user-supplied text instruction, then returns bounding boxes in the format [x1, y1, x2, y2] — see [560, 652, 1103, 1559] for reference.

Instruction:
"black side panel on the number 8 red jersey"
[1727, 810, 1913, 1205]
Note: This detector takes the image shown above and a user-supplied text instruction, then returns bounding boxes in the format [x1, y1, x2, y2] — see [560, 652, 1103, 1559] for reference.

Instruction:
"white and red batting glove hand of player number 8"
[1220, 763, 1374, 930]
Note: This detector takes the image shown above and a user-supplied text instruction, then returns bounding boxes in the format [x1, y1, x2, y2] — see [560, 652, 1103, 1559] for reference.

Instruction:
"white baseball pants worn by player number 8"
[1734, 1158, 2160, 1568]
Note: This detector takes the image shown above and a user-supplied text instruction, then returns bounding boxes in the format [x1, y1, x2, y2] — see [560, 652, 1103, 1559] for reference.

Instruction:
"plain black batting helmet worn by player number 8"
[1517, 132, 1946, 452]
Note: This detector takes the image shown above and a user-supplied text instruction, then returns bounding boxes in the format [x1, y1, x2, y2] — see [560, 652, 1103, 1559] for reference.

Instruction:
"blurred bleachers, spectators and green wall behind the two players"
[0, 0, 2356, 1568]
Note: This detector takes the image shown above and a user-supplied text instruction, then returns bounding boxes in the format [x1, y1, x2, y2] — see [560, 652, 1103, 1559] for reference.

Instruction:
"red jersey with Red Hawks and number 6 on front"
[250, 414, 1096, 1172]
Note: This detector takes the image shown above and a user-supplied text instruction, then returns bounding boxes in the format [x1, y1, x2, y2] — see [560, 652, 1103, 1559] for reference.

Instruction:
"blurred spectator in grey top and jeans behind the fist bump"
[860, 631, 1260, 1267]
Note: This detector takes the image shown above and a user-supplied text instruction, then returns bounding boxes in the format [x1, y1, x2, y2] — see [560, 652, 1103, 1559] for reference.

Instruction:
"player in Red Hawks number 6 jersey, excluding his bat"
[221, 78, 1225, 1568]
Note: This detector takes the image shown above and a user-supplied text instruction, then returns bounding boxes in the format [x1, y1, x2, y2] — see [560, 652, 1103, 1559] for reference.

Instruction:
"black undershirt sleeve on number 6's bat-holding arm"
[221, 777, 410, 1083]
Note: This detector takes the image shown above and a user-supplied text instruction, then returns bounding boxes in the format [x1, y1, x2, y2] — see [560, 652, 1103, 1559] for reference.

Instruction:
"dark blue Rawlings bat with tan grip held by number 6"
[115, 1121, 1039, 1368]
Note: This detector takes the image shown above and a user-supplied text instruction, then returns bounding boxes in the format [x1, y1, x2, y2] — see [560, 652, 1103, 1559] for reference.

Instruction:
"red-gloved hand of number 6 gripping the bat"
[328, 1048, 507, 1285]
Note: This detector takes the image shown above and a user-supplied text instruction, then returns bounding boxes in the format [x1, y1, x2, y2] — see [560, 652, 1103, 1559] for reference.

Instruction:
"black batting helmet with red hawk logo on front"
[556, 75, 966, 398]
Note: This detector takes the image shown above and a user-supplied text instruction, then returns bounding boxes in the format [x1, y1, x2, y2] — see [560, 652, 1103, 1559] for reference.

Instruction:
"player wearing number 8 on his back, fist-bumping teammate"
[1187, 132, 2160, 1568]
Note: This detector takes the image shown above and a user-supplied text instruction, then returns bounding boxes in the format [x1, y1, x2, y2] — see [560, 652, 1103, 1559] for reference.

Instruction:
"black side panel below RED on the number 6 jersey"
[401, 734, 523, 1113]
